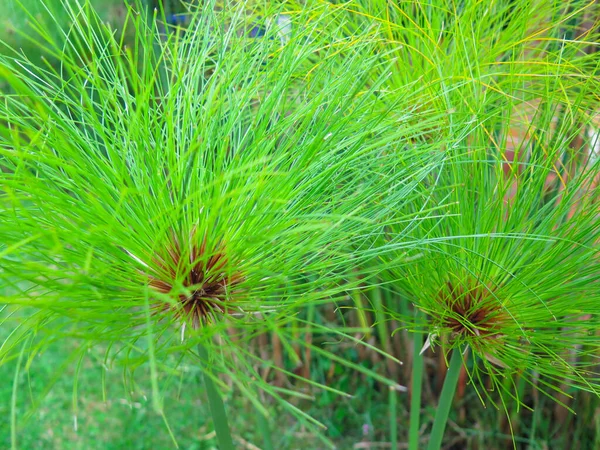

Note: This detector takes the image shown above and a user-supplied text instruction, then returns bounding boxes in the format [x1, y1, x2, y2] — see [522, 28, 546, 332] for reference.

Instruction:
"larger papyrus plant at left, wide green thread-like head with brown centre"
[0, 1, 429, 448]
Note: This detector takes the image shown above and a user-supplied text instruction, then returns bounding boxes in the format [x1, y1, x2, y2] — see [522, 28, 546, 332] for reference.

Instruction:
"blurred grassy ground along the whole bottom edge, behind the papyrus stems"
[0, 336, 599, 450]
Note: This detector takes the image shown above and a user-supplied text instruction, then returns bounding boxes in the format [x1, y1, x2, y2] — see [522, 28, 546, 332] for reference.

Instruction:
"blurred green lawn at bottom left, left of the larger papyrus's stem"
[0, 340, 227, 449]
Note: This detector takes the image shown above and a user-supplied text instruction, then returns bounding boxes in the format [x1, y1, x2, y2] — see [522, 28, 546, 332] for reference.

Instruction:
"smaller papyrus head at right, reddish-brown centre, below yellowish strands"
[390, 111, 600, 442]
